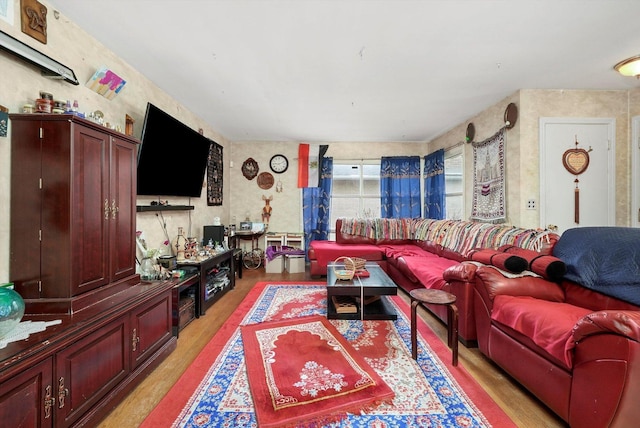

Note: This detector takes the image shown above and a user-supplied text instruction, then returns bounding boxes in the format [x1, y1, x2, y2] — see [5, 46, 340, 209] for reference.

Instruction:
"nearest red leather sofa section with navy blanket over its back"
[468, 227, 640, 428]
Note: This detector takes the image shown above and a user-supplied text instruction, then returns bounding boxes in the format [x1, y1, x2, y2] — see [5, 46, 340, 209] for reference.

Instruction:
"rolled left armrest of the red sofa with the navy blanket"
[476, 266, 564, 302]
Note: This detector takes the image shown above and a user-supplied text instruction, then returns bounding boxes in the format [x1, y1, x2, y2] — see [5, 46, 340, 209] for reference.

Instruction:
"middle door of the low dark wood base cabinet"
[54, 315, 130, 427]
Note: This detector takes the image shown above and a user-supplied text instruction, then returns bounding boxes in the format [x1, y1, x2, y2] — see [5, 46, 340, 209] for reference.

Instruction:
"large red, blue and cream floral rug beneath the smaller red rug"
[142, 283, 515, 428]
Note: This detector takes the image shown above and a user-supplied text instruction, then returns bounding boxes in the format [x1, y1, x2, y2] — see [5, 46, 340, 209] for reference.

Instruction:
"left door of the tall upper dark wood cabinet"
[69, 125, 111, 296]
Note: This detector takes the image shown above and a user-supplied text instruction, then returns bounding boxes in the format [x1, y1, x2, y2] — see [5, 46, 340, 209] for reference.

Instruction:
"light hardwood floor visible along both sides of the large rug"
[99, 268, 567, 428]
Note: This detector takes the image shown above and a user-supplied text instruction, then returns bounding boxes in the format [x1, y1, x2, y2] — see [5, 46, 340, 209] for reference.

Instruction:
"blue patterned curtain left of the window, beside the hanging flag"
[302, 157, 333, 254]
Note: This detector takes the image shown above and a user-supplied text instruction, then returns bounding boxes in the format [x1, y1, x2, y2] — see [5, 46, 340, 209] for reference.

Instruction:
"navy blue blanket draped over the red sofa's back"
[553, 227, 640, 305]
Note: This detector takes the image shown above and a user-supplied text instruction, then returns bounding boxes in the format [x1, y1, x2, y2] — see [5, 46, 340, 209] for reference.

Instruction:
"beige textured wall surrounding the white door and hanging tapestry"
[430, 89, 640, 228]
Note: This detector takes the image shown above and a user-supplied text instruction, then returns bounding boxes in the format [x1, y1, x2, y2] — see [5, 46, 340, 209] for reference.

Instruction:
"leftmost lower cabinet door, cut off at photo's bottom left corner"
[0, 358, 56, 428]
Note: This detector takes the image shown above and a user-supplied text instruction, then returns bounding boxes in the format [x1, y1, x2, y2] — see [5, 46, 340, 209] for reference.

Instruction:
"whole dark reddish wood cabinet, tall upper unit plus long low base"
[0, 114, 177, 428]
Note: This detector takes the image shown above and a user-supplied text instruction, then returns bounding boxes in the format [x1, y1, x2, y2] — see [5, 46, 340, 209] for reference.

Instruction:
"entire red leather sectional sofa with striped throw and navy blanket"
[309, 220, 640, 428]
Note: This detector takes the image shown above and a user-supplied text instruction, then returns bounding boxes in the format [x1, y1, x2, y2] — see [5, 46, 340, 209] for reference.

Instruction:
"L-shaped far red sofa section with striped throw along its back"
[308, 219, 542, 346]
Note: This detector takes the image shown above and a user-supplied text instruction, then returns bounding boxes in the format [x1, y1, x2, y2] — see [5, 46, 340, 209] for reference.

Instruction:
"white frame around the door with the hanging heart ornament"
[539, 117, 616, 228]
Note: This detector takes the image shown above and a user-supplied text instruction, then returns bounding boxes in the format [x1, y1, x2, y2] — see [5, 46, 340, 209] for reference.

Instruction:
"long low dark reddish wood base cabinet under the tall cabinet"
[0, 282, 176, 428]
